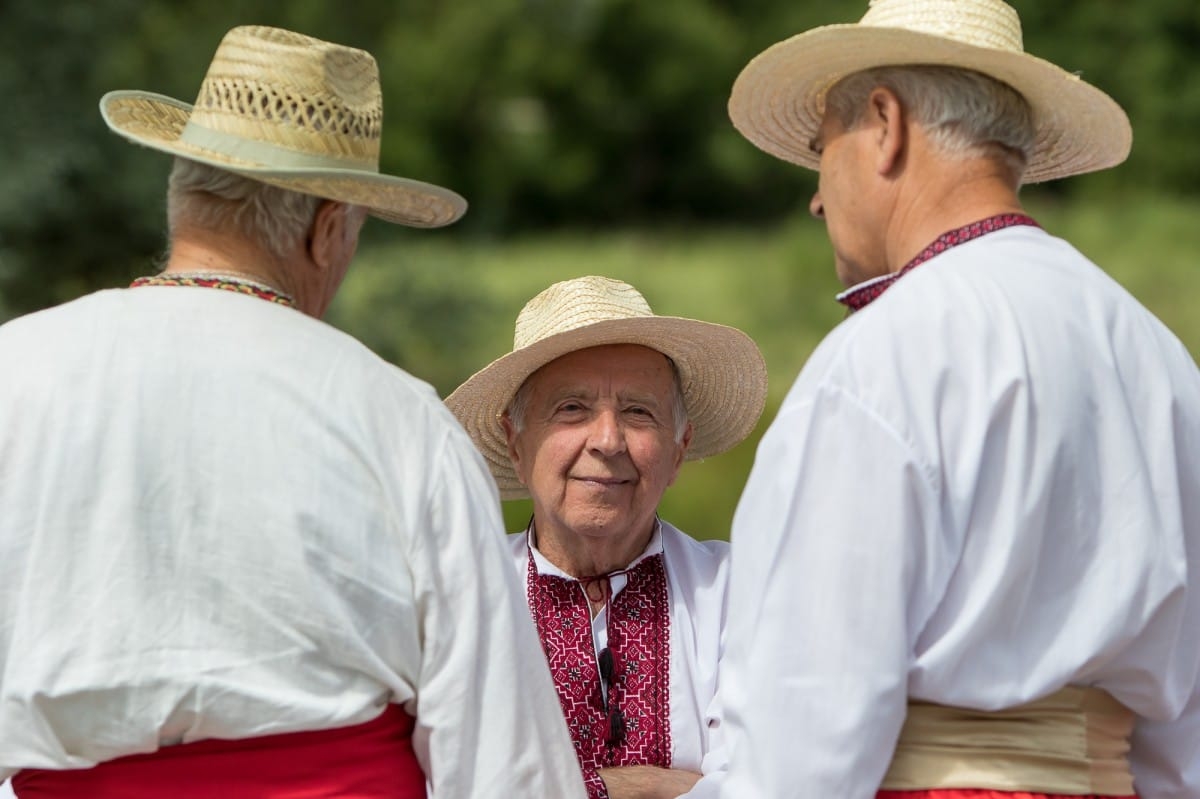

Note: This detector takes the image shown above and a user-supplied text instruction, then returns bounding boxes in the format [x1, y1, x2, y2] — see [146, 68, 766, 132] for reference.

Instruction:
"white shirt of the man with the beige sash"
[689, 227, 1200, 799]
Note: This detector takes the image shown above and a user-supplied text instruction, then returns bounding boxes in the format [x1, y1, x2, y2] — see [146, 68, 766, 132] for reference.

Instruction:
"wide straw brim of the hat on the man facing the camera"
[445, 317, 767, 499]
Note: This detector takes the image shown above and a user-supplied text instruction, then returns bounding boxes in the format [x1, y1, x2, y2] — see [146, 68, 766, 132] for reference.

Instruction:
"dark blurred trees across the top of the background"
[0, 0, 1200, 319]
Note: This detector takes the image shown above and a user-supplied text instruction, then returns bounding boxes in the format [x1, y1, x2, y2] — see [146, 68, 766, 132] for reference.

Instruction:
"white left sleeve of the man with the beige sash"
[710, 386, 943, 799]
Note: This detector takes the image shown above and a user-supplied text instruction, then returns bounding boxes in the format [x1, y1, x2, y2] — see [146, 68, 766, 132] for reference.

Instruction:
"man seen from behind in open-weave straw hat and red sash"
[0, 28, 583, 799]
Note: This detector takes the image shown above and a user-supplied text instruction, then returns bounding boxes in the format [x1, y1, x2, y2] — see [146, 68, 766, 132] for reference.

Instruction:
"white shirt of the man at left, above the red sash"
[0, 287, 584, 799]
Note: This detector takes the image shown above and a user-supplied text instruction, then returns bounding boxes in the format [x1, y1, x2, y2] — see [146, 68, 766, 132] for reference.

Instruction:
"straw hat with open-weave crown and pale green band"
[100, 26, 467, 228]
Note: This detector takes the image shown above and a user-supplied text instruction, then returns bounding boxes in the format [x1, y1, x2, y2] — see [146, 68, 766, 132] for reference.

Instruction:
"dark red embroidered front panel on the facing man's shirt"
[527, 553, 671, 799]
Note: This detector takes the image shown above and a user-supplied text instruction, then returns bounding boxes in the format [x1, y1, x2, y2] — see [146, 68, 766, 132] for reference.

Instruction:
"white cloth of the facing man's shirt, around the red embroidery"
[509, 521, 730, 773]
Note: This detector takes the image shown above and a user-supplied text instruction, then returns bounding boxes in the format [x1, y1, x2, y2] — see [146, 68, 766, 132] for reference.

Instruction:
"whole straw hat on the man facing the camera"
[446, 277, 767, 499]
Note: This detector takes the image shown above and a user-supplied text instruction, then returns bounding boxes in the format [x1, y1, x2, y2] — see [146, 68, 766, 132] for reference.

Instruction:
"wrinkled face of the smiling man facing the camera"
[506, 344, 691, 548]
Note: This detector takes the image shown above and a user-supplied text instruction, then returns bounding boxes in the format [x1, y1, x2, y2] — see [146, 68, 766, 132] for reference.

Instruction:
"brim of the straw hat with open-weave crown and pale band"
[100, 91, 467, 228]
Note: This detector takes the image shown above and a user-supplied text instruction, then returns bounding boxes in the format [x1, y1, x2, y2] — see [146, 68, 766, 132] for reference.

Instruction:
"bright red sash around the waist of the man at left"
[12, 704, 426, 799]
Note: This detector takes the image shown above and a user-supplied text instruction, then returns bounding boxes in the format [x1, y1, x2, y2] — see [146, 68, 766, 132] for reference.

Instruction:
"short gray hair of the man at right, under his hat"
[826, 65, 1037, 179]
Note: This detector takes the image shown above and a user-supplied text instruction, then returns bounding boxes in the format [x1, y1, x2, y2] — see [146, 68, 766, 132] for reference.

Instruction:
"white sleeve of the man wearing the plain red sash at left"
[412, 434, 586, 799]
